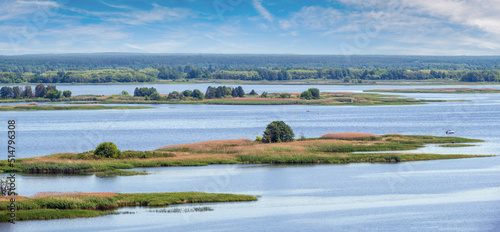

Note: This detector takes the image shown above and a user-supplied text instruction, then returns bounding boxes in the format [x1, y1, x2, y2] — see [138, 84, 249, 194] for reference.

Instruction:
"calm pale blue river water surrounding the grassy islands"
[0, 85, 500, 231]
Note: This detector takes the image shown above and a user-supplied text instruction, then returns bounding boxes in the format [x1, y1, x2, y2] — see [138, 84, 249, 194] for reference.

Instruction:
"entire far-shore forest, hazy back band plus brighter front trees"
[0, 53, 500, 83]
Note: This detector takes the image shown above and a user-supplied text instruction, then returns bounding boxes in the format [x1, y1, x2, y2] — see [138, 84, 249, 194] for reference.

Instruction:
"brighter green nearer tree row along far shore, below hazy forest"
[0, 65, 500, 83]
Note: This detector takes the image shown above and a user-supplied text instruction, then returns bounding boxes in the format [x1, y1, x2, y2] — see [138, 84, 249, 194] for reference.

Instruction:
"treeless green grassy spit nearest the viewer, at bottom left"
[0, 192, 257, 222]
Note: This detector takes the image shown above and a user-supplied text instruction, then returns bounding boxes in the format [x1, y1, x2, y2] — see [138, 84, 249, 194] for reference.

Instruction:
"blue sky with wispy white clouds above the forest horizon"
[0, 0, 500, 55]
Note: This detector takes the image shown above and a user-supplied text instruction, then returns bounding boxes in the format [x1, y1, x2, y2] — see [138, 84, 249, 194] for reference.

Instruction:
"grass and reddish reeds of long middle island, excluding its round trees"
[0, 133, 488, 176]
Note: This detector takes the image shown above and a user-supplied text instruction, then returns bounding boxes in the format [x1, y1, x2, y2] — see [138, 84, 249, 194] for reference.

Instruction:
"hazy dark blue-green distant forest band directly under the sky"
[0, 53, 500, 74]
